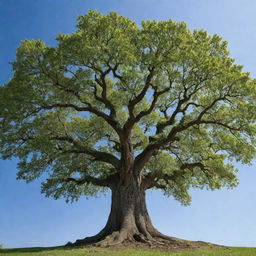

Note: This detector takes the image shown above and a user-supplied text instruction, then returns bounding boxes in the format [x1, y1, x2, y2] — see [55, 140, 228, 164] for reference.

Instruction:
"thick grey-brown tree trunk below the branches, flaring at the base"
[68, 174, 170, 245]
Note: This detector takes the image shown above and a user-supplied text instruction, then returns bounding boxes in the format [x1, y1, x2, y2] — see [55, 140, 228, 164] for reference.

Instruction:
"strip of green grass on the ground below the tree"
[0, 247, 256, 256]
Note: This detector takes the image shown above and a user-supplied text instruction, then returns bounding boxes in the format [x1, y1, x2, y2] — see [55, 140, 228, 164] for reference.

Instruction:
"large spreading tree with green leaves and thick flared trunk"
[0, 11, 256, 247]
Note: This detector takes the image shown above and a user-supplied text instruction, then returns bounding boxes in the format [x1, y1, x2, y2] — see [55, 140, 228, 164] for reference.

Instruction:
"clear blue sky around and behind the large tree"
[0, 0, 256, 248]
